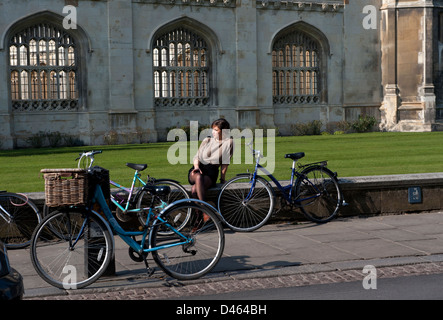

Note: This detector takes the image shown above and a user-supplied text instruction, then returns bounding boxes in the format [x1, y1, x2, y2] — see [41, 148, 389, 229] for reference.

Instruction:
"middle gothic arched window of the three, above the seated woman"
[152, 27, 210, 106]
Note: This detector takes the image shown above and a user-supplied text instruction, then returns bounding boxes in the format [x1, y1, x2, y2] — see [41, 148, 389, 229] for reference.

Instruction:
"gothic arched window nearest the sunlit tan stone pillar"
[272, 29, 322, 104]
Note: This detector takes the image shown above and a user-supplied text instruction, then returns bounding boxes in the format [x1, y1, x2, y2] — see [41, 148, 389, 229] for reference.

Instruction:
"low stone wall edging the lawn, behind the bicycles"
[24, 172, 443, 221]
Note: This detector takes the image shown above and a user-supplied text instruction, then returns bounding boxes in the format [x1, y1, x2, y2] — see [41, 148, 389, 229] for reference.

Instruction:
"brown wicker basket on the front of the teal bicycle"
[40, 169, 88, 207]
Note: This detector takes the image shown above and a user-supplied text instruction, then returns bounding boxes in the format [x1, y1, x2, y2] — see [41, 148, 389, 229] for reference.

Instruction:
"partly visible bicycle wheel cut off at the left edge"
[0, 192, 41, 249]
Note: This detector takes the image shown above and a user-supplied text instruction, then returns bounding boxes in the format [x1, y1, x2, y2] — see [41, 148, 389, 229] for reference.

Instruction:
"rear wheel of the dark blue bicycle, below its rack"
[295, 166, 342, 223]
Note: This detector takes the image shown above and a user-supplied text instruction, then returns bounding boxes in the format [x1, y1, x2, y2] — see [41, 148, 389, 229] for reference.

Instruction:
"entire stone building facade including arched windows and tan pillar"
[0, 0, 443, 148]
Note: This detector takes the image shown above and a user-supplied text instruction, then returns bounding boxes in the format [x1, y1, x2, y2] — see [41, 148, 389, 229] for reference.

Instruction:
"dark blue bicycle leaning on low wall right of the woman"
[217, 142, 346, 232]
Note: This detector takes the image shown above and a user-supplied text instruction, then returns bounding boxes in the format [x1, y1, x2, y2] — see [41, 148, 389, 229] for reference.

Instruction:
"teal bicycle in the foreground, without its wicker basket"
[30, 167, 225, 289]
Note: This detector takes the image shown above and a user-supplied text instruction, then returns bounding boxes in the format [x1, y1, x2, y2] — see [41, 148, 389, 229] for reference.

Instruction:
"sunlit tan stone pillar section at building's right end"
[381, 0, 443, 131]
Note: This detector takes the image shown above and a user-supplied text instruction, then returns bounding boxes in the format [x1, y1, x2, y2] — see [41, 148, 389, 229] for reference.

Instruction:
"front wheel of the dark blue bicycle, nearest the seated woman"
[217, 175, 274, 232]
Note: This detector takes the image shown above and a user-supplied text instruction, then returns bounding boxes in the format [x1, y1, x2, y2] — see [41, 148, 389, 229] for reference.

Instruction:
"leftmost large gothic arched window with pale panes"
[9, 23, 79, 112]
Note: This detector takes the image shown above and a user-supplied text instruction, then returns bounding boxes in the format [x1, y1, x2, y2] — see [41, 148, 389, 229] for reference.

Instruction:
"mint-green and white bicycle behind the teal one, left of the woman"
[75, 150, 191, 230]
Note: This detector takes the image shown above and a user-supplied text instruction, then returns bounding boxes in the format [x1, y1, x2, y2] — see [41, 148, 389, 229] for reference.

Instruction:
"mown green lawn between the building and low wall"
[0, 132, 443, 192]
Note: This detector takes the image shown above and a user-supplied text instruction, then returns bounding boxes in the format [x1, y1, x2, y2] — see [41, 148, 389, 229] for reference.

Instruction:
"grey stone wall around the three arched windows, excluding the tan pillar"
[0, 0, 388, 148]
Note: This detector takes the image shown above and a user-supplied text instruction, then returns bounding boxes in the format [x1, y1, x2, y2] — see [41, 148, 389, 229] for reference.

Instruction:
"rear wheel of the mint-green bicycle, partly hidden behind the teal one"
[137, 179, 191, 235]
